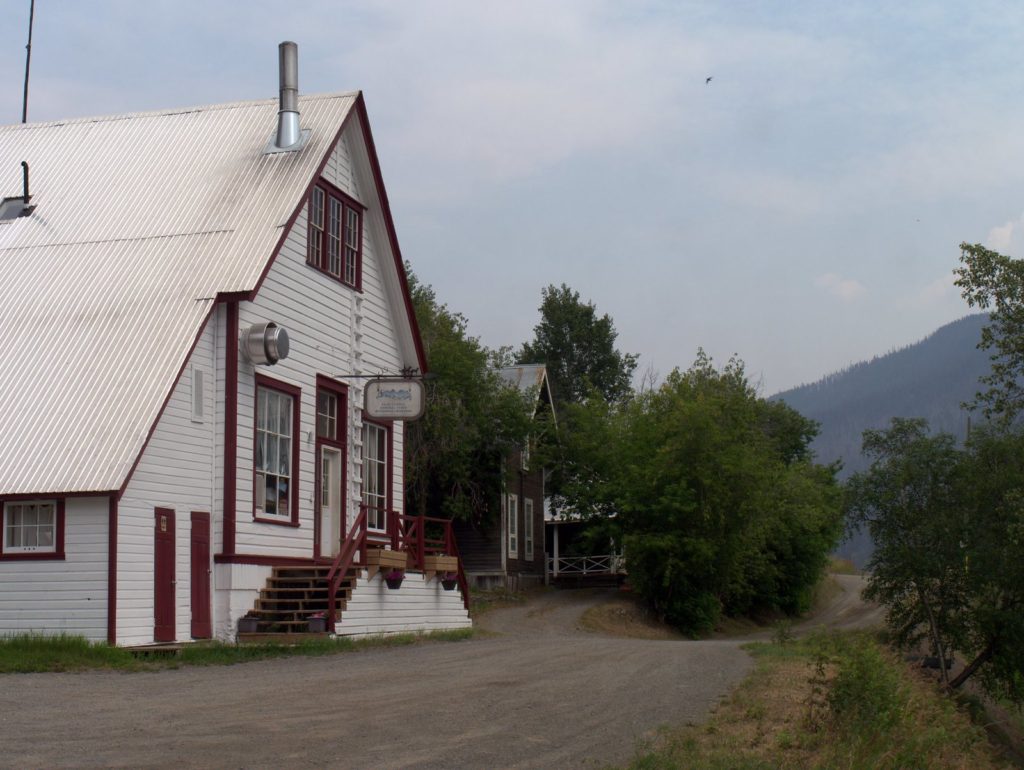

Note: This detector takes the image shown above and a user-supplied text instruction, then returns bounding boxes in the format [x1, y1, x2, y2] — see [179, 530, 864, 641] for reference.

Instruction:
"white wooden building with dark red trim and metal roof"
[0, 43, 470, 645]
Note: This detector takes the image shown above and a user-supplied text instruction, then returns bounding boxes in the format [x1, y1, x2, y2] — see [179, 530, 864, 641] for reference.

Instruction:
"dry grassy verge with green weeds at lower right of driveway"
[629, 633, 1008, 770]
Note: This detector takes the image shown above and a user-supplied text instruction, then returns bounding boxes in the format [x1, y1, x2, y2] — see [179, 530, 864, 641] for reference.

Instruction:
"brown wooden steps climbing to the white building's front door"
[239, 565, 356, 643]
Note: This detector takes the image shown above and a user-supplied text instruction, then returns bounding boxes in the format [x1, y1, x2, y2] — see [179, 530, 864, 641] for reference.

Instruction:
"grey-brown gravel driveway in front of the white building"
[0, 592, 880, 768]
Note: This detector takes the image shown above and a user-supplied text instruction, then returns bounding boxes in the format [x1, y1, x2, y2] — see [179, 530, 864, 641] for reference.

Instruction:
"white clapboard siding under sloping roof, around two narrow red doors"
[117, 310, 223, 645]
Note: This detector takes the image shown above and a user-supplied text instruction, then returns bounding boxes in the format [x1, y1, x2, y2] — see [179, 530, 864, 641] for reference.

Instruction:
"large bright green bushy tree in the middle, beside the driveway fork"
[562, 352, 842, 633]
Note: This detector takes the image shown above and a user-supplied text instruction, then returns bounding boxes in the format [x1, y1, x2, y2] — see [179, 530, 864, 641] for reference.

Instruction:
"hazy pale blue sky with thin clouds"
[0, 0, 1024, 394]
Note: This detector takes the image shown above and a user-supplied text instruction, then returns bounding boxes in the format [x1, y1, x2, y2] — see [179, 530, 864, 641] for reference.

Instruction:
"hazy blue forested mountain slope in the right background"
[772, 313, 989, 566]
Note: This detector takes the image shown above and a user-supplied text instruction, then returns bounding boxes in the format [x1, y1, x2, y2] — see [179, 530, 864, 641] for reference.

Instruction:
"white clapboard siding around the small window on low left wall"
[0, 498, 109, 641]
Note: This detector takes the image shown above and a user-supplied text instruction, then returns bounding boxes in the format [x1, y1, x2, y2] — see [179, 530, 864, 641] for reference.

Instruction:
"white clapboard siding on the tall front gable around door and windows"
[232, 115, 403, 561]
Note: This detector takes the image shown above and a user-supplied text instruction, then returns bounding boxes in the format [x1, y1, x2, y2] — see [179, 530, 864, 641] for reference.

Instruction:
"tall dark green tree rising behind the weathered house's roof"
[519, 284, 637, 405]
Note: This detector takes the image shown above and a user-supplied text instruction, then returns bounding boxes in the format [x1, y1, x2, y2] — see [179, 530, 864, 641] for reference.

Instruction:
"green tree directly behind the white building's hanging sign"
[406, 266, 534, 522]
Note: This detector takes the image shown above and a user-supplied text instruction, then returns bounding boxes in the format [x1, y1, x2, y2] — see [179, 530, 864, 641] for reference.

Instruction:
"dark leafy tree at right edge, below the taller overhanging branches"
[848, 419, 1024, 702]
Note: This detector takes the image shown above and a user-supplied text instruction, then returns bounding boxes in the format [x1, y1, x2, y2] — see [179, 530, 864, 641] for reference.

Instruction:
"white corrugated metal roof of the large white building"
[0, 93, 357, 495]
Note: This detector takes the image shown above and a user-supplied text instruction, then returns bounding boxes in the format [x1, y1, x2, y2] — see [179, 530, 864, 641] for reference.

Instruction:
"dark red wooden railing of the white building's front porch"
[327, 506, 469, 633]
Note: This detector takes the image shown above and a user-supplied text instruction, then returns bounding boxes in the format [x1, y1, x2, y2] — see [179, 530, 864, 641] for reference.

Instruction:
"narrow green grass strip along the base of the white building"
[0, 629, 473, 674]
